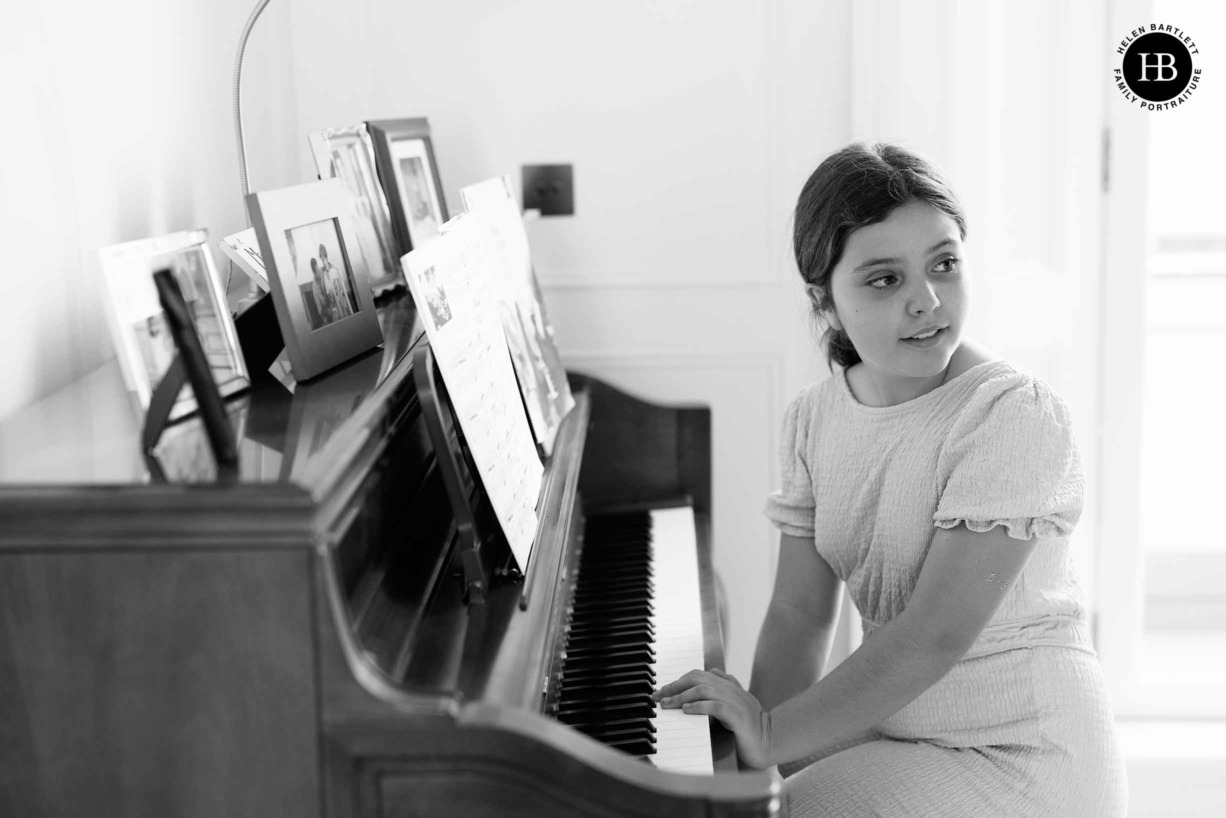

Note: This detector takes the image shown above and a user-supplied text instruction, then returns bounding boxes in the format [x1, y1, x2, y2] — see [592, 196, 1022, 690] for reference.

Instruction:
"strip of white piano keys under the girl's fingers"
[649, 508, 715, 775]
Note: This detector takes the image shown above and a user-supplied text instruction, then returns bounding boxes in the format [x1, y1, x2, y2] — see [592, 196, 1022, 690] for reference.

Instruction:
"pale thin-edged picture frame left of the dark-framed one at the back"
[307, 123, 407, 296]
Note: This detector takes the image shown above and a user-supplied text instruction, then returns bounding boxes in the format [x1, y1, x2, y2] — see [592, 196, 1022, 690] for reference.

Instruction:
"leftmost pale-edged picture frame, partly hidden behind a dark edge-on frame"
[98, 229, 251, 422]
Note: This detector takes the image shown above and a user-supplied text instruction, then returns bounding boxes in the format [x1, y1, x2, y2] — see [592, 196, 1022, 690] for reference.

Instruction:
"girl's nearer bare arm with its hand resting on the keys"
[657, 525, 1035, 766]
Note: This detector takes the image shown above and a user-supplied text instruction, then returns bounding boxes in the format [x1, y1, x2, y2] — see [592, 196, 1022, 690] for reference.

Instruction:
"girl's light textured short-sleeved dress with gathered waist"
[766, 362, 1127, 818]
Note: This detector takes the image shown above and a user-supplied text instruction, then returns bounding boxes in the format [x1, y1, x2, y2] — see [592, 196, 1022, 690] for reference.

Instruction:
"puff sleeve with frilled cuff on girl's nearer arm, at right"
[933, 373, 1085, 540]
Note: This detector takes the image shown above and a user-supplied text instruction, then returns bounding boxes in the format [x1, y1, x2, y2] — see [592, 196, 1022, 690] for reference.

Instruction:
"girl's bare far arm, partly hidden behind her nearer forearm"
[749, 533, 842, 709]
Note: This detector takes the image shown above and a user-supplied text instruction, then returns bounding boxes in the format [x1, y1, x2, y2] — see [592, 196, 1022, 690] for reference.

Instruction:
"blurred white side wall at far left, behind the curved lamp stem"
[0, 0, 295, 417]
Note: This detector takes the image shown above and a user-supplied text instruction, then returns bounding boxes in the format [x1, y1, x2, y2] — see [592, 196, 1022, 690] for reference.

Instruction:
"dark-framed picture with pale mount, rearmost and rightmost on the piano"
[367, 117, 450, 256]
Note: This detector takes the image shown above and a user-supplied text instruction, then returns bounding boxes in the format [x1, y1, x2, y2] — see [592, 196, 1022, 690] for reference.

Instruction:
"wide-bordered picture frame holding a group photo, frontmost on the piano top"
[248, 179, 383, 380]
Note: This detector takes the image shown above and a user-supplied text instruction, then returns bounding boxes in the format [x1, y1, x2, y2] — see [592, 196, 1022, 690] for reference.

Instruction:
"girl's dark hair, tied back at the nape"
[792, 142, 966, 372]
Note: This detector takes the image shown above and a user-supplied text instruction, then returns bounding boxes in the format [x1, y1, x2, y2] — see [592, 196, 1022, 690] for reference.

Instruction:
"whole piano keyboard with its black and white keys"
[555, 508, 714, 775]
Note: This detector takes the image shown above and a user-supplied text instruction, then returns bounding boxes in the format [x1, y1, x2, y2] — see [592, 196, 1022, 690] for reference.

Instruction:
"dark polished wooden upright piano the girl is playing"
[0, 297, 786, 818]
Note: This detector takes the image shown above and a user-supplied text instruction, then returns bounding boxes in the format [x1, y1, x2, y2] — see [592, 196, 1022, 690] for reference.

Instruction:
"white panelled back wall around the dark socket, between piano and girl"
[281, 0, 848, 681]
